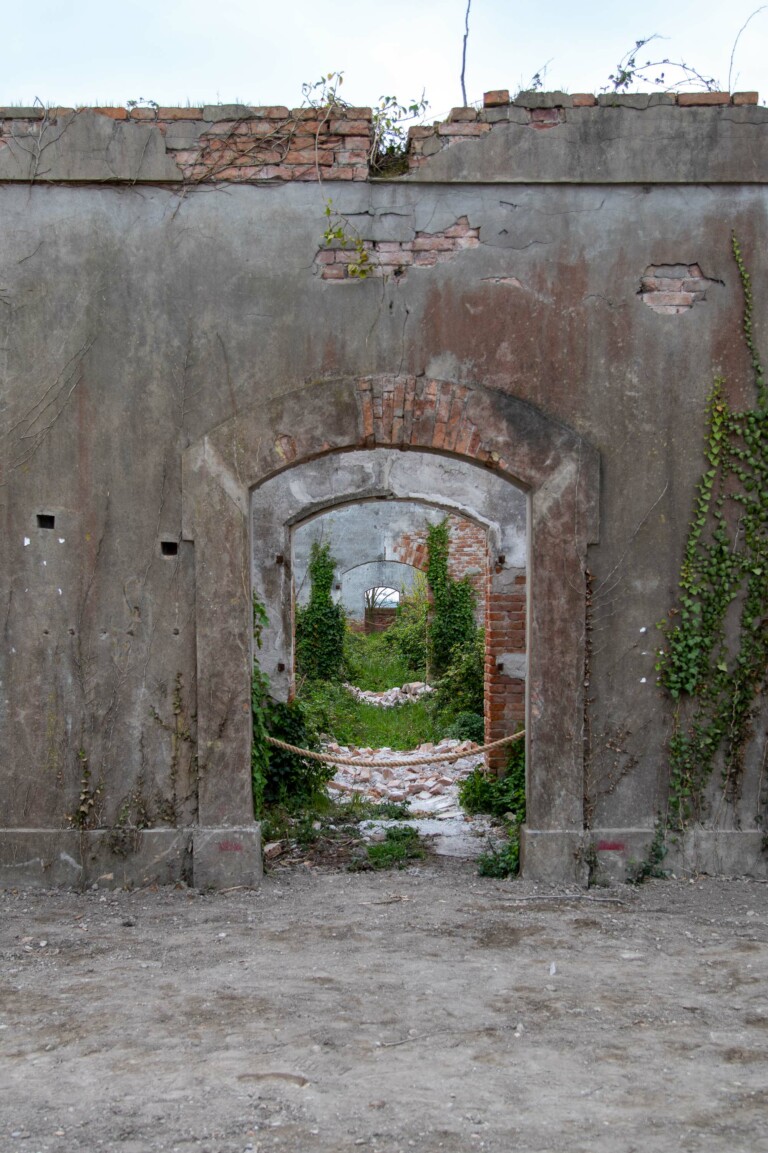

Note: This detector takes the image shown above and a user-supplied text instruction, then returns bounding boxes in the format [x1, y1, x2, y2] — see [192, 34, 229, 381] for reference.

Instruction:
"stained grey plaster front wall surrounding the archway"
[0, 99, 768, 876]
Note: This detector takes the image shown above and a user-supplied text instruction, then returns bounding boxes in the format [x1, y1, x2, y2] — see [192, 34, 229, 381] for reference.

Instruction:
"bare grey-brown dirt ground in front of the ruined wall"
[0, 859, 768, 1153]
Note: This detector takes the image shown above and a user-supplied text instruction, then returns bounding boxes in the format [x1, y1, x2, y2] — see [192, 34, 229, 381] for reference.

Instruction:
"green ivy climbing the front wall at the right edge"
[656, 236, 768, 829]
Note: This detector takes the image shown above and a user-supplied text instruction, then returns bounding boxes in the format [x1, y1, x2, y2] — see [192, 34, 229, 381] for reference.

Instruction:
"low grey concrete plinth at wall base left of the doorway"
[0, 824, 263, 889]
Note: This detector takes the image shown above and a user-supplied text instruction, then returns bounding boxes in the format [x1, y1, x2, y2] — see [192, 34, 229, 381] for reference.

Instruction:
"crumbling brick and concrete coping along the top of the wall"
[0, 89, 768, 186]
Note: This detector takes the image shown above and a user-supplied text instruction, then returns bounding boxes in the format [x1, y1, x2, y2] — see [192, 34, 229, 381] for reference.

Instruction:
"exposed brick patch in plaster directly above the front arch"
[315, 217, 480, 280]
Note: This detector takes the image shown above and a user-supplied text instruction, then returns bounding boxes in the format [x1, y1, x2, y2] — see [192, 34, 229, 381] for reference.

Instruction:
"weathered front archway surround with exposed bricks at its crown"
[182, 376, 598, 879]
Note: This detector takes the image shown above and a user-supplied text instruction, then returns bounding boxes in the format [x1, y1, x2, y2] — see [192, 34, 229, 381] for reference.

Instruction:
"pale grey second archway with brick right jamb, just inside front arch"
[251, 447, 529, 767]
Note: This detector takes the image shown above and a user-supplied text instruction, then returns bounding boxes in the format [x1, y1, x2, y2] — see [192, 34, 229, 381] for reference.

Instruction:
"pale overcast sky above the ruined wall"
[5, 0, 768, 119]
